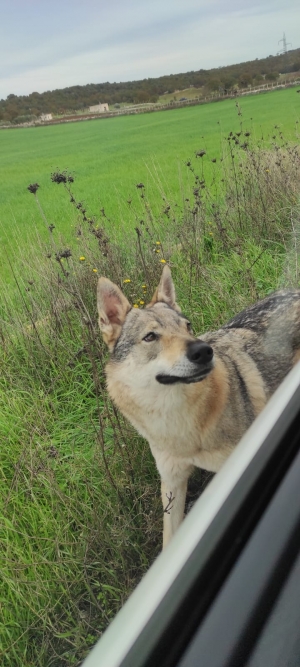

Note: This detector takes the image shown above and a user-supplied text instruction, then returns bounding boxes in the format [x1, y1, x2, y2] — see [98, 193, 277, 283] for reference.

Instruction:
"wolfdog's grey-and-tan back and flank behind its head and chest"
[196, 290, 300, 454]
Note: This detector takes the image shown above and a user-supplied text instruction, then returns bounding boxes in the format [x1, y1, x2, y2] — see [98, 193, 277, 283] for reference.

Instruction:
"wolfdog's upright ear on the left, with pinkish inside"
[97, 277, 131, 350]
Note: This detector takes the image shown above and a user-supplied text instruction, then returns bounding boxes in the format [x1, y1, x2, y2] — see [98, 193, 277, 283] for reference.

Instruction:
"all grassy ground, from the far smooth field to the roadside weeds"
[0, 90, 300, 667]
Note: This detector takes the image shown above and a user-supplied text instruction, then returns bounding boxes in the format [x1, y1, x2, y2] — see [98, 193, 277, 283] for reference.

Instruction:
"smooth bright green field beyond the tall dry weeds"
[0, 89, 299, 279]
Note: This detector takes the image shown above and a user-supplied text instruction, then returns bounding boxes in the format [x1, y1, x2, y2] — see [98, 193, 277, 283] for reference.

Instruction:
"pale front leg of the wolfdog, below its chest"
[161, 479, 187, 549]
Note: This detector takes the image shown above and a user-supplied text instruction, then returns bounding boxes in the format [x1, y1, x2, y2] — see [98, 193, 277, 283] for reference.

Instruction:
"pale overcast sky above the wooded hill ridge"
[0, 0, 300, 99]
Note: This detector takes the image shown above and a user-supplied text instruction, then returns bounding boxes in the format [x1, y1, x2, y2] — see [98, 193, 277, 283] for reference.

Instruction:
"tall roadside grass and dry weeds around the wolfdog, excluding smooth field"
[0, 124, 300, 667]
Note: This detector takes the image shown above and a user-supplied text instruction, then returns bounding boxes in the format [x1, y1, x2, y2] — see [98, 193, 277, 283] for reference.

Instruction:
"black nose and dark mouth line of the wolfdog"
[156, 340, 214, 384]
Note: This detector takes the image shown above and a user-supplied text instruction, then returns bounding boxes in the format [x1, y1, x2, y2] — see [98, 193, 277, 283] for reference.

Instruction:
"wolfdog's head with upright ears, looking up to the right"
[98, 266, 214, 387]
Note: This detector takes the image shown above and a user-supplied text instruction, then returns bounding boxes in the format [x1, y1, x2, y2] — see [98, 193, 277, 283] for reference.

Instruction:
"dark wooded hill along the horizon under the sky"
[0, 49, 300, 123]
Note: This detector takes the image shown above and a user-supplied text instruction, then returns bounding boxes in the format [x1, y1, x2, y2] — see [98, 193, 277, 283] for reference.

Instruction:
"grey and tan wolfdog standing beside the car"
[98, 265, 300, 547]
